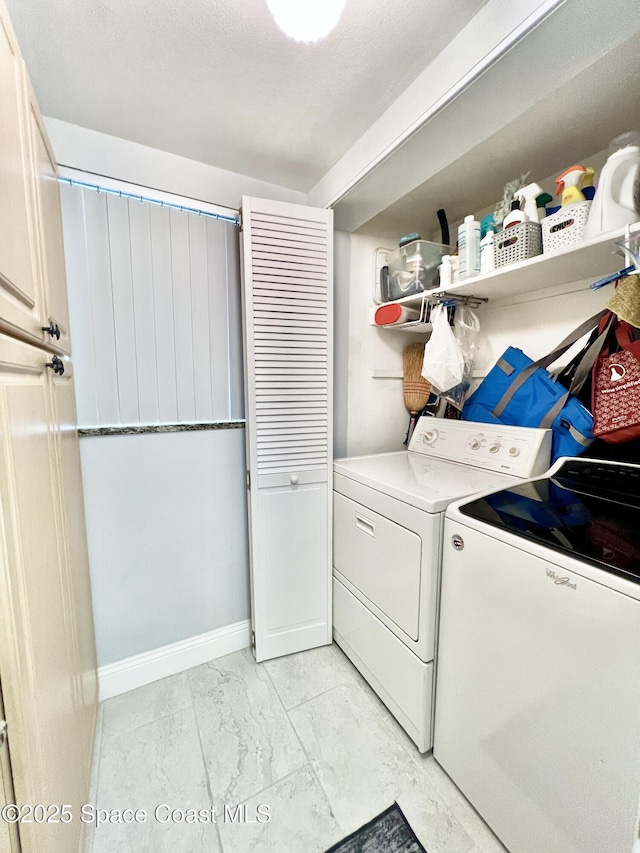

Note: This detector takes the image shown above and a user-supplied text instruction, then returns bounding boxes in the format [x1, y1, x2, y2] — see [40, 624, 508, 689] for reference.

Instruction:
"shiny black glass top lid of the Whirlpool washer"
[460, 459, 640, 583]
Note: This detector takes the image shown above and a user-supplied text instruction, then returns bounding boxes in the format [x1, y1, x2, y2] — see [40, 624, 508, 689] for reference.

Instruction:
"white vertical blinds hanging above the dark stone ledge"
[62, 184, 242, 427]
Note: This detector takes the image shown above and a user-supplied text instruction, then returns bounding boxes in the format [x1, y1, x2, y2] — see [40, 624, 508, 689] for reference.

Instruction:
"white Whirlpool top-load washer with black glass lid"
[434, 459, 640, 853]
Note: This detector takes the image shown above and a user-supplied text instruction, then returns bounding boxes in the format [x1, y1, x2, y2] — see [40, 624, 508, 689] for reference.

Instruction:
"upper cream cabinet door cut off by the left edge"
[0, 10, 43, 340]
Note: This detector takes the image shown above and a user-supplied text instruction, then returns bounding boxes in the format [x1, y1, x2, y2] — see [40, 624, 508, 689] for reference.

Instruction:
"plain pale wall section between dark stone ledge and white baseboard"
[80, 429, 249, 666]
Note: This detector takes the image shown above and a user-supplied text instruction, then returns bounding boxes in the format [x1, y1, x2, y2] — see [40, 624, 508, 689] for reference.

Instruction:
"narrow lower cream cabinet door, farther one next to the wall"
[49, 362, 98, 789]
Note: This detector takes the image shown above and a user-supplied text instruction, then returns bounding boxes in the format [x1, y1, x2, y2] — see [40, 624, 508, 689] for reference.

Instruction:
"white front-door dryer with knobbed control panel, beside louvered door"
[333, 417, 551, 752]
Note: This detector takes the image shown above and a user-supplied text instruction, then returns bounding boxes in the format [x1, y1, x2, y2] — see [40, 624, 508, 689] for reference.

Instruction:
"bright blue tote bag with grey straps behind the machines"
[462, 311, 609, 462]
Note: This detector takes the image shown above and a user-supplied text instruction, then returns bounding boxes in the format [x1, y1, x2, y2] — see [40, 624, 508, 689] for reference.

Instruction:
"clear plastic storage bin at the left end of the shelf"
[382, 240, 450, 302]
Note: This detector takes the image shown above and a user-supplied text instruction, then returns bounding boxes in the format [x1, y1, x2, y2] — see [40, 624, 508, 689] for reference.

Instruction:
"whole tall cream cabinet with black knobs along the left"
[0, 0, 97, 853]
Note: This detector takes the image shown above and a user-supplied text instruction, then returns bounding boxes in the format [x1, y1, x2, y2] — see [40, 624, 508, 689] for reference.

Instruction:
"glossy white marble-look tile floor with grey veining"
[86, 645, 506, 853]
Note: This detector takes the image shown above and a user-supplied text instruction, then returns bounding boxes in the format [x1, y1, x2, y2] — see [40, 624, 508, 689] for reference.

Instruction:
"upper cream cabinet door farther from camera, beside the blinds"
[27, 81, 71, 353]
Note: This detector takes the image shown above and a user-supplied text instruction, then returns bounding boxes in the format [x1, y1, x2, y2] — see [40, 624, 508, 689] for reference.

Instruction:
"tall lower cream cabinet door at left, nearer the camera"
[0, 336, 87, 853]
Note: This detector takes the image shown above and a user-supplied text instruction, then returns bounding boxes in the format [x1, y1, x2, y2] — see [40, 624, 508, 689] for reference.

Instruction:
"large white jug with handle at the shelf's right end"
[584, 131, 640, 240]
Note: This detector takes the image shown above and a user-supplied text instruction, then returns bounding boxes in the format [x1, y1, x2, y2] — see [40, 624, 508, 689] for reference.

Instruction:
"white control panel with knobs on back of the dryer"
[409, 416, 551, 477]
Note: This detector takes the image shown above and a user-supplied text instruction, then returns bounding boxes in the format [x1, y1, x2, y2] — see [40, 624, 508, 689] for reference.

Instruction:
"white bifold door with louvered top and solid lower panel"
[241, 197, 333, 661]
